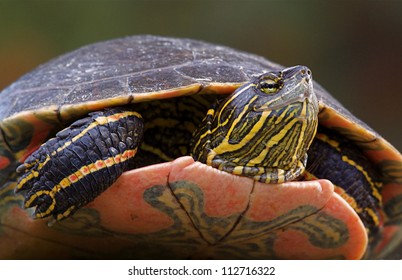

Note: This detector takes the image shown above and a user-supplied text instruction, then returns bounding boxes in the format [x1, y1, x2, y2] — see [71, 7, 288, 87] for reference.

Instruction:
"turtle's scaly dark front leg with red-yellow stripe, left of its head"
[16, 108, 144, 220]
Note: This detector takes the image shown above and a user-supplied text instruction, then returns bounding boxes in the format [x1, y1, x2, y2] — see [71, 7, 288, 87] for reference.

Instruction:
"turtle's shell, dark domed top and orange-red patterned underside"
[0, 36, 402, 259]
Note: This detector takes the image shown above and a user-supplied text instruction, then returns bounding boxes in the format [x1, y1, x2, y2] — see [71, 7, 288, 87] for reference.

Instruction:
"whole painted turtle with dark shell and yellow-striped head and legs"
[0, 35, 402, 259]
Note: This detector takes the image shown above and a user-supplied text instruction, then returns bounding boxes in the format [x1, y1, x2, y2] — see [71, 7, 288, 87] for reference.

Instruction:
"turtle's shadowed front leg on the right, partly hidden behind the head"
[307, 128, 382, 239]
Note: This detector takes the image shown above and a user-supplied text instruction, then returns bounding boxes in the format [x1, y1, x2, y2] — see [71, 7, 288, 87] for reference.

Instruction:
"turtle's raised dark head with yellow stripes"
[193, 66, 318, 183]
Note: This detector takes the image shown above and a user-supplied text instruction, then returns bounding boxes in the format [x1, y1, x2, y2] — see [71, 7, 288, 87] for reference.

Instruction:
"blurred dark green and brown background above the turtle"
[0, 0, 402, 151]
